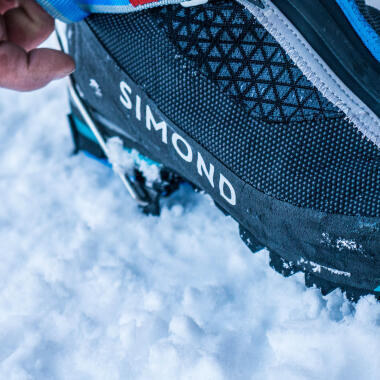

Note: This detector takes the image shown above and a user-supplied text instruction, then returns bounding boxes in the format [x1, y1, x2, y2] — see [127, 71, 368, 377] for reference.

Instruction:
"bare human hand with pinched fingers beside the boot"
[0, 0, 75, 91]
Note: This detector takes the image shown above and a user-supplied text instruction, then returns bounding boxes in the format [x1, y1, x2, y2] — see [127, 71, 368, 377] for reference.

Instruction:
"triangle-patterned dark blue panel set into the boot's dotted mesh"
[155, 0, 338, 121]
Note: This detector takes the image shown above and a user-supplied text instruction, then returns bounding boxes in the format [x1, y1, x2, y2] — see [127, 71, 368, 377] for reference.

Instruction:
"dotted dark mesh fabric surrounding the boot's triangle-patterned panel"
[87, 1, 380, 217]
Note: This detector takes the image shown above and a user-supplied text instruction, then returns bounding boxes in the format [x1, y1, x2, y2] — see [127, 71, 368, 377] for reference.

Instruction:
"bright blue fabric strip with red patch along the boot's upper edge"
[37, 0, 202, 23]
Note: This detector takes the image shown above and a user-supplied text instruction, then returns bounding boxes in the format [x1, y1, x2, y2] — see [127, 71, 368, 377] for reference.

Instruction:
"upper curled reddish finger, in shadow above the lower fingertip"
[4, 0, 54, 51]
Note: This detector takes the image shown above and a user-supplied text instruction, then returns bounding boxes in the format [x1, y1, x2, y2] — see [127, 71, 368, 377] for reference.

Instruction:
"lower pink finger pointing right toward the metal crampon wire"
[0, 42, 75, 91]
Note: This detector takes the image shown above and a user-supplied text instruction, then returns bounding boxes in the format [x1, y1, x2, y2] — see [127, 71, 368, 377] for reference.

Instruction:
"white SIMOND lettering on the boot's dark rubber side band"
[120, 81, 236, 206]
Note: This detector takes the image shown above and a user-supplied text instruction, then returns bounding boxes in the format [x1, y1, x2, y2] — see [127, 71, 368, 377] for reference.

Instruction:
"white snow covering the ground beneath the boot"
[0, 43, 380, 380]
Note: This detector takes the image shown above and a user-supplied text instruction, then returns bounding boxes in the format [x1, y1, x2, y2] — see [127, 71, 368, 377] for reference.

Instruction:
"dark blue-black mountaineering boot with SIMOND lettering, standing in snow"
[60, 0, 380, 298]
